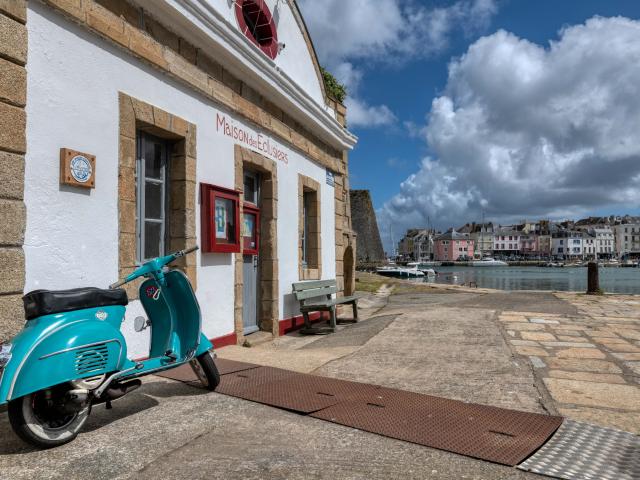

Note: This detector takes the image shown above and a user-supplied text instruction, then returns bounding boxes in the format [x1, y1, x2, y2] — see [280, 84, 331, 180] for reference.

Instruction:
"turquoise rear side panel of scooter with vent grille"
[0, 306, 127, 404]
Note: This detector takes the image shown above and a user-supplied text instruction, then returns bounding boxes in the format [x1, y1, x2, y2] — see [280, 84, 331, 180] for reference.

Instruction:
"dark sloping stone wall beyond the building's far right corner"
[350, 190, 384, 265]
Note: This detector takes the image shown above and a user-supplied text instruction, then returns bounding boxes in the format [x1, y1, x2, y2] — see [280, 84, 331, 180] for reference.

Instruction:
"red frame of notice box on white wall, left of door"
[200, 183, 240, 253]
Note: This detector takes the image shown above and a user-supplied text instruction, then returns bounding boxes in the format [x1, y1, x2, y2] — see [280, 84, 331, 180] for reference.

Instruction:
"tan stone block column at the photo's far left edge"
[0, 0, 27, 341]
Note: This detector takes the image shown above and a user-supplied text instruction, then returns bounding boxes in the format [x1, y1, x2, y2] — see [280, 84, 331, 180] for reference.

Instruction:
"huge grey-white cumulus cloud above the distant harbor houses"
[378, 17, 640, 242]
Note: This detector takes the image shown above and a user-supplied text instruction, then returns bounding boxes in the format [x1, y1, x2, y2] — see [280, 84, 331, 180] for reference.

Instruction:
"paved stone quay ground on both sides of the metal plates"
[0, 273, 640, 479]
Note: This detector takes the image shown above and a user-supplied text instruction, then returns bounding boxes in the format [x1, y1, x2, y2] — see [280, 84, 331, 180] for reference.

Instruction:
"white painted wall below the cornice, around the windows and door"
[24, 2, 335, 357]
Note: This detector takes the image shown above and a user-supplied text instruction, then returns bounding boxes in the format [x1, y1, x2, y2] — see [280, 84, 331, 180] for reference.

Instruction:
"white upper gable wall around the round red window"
[202, 0, 325, 108]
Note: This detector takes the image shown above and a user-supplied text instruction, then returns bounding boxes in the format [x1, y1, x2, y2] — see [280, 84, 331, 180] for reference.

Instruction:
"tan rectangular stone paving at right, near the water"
[499, 293, 640, 434]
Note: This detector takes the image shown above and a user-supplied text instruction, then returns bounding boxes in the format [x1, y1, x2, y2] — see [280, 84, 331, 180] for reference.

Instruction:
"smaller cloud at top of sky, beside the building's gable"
[299, 0, 497, 128]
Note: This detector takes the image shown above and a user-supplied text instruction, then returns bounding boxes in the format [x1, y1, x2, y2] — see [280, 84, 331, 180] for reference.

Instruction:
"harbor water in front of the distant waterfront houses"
[424, 266, 640, 294]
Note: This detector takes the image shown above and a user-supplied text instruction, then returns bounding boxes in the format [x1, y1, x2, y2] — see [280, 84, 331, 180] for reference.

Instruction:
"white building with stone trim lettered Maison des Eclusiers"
[0, 0, 356, 357]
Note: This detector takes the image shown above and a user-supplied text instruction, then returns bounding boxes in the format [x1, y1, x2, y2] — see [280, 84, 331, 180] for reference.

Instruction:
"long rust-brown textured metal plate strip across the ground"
[165, 360, 562, 466]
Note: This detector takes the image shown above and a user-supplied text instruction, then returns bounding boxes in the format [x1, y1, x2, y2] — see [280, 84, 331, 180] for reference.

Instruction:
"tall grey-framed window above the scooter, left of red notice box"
[136, 132, 169, 262]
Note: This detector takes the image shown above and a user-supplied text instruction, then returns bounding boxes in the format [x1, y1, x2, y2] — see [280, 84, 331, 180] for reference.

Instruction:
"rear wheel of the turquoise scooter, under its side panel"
[7, 390, 91, 448]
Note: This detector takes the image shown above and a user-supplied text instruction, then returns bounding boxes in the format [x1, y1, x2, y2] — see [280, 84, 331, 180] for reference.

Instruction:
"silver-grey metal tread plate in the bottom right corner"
[518, 420, 640, 480]
